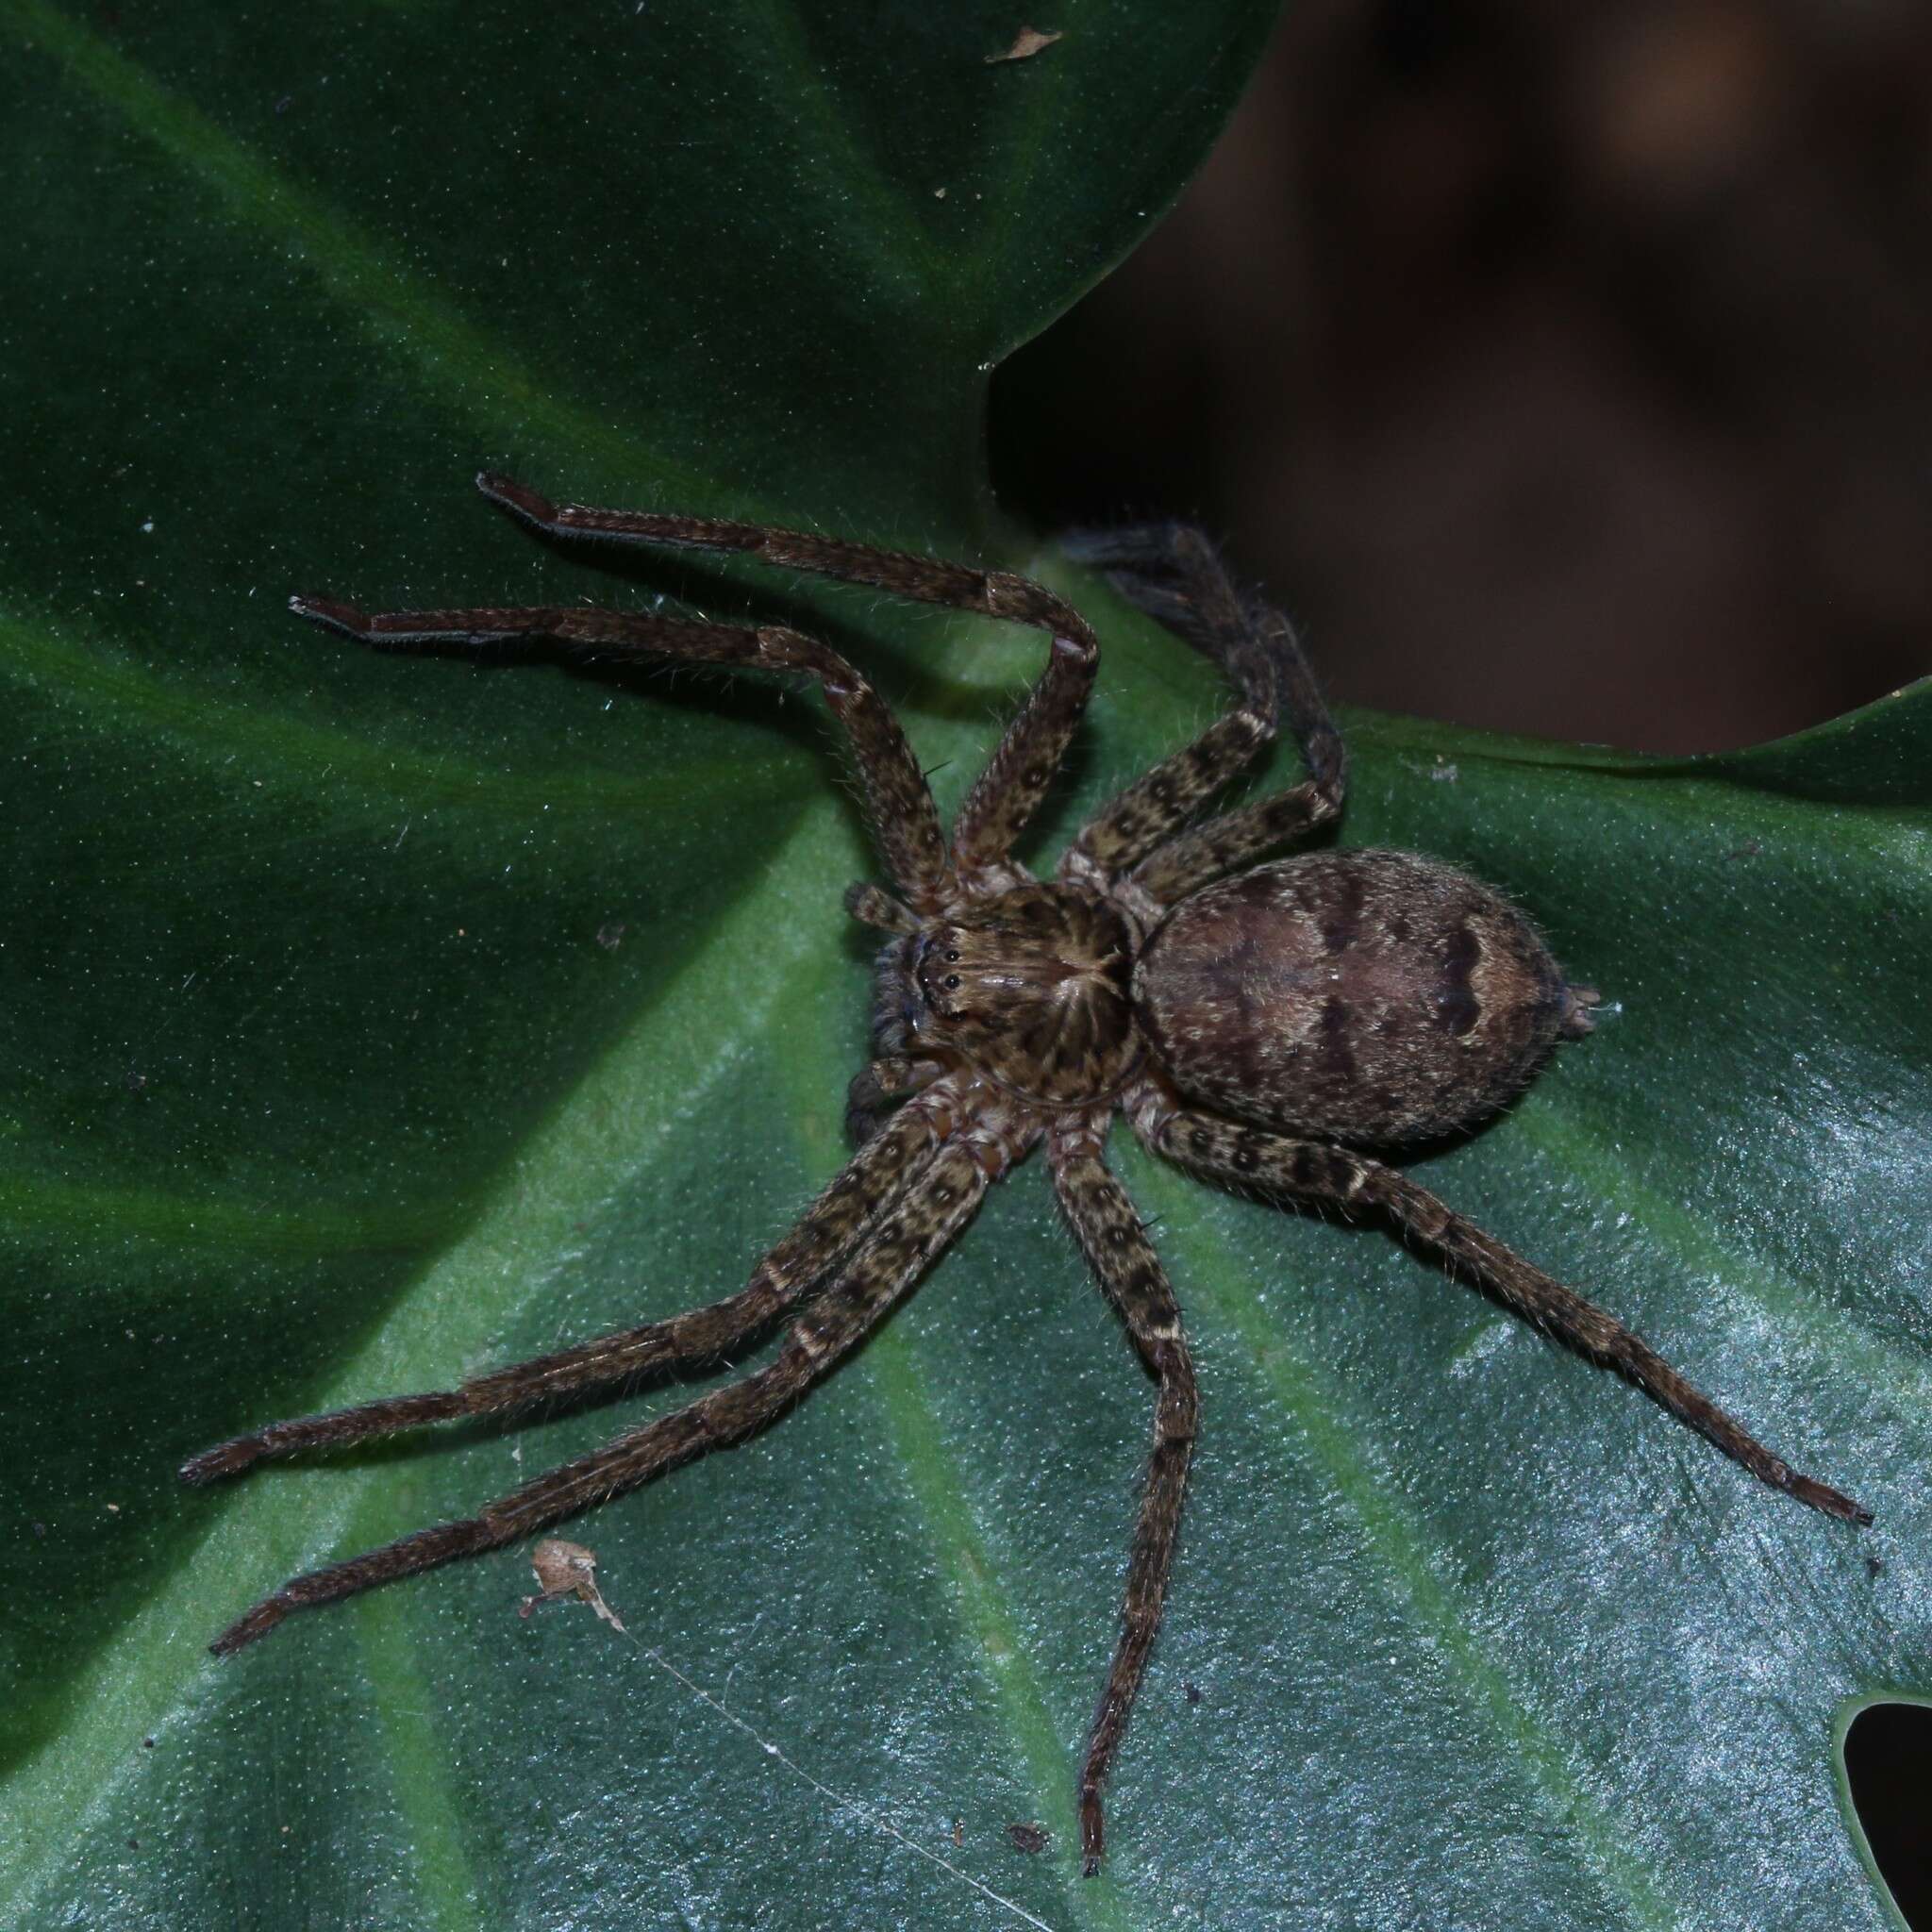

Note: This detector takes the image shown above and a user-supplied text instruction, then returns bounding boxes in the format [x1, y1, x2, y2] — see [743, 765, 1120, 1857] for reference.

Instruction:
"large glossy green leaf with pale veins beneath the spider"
[0, 0, 1932, 1928]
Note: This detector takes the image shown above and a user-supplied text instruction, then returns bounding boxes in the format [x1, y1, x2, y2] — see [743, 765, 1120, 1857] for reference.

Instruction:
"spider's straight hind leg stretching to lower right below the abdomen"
[1128, 1084, 1873, 1523]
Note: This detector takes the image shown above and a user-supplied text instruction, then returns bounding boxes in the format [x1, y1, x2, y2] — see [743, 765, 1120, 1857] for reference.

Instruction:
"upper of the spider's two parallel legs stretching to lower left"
[182, 1095, 953, 1482]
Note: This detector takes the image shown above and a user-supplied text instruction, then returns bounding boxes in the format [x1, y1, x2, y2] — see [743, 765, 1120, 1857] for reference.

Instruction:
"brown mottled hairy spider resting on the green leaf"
[182, 474, 1870, 1876]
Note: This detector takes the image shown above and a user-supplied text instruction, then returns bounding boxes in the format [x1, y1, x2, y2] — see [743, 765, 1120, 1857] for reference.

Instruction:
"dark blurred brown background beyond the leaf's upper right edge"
[993, 0, 1932, 752]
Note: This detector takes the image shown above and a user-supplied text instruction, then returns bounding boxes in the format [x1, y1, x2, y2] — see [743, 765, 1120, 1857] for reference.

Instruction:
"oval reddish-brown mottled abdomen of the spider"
[1134, 852, 1591, 1145]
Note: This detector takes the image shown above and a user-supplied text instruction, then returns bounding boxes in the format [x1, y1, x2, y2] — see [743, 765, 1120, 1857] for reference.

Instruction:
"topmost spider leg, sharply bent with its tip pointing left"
[477, 472, 1099, 884]
